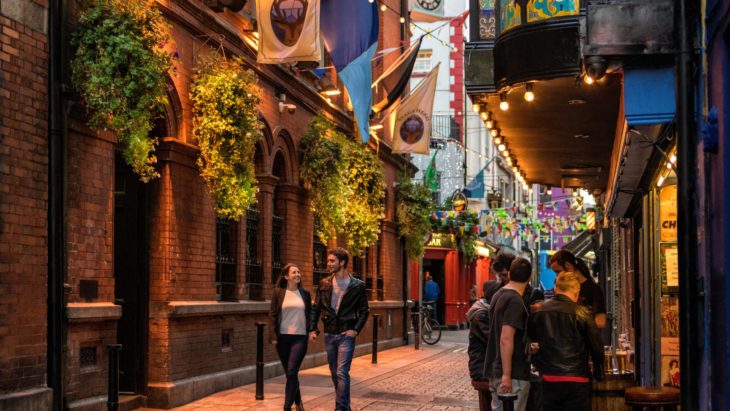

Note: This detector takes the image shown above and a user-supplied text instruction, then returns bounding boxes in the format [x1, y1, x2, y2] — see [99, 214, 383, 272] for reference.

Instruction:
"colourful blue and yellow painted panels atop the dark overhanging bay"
[499, 0, 580, 33]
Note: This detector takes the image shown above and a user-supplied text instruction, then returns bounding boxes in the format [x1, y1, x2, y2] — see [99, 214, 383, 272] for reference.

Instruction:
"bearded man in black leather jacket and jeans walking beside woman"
[309, 247, 370, 411]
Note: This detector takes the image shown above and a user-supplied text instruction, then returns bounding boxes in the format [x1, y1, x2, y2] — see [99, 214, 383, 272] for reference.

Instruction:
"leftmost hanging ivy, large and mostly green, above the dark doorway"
[71, 0, 172, 182]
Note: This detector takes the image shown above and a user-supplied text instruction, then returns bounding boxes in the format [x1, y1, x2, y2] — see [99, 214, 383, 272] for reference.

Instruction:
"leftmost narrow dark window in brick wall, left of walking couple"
[215, 219, 238, 301]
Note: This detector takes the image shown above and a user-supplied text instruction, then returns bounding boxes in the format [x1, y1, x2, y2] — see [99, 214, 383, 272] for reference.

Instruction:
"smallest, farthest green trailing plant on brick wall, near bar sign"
[395, 174, 434, 259]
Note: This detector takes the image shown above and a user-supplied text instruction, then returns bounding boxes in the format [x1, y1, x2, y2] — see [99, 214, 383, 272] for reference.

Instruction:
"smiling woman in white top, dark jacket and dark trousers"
[269, 264, 312, 411]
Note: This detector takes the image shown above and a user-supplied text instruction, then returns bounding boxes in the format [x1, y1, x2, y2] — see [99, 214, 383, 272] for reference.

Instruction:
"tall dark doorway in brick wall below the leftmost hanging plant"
[114, 153, 149, 393]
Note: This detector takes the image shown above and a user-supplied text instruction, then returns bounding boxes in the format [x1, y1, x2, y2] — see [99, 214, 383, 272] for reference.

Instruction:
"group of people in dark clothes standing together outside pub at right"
[467, 250, 606, 411]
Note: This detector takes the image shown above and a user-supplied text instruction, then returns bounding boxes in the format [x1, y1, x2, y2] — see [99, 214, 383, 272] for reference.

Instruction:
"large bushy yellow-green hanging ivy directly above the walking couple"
[301, 115, 385, 255]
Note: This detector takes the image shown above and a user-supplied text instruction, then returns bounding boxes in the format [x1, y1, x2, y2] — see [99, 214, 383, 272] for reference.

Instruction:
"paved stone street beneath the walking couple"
[143, 331, 479, 411]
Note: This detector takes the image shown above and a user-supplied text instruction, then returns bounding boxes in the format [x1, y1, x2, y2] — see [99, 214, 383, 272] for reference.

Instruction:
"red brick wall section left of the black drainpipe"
[0, 1, 48, 392]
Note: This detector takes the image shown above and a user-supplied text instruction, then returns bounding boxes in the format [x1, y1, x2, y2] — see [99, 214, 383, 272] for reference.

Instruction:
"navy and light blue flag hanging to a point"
[320, 0, 379, 143]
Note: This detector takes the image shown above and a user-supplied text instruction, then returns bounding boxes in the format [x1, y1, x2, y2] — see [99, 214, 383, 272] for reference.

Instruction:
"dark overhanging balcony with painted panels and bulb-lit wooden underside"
[464, 0, 674, 191]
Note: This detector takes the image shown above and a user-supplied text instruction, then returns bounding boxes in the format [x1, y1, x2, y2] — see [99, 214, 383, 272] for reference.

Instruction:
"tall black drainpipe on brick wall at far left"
[47, 0, 66, 411]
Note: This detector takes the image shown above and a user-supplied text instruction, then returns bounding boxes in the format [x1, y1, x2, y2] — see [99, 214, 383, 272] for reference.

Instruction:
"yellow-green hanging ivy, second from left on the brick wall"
[190, 57, 263, 220]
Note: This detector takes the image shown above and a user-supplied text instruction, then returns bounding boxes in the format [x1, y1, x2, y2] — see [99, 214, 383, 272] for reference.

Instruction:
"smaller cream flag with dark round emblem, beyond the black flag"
[388, 65, 439, 154]
